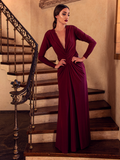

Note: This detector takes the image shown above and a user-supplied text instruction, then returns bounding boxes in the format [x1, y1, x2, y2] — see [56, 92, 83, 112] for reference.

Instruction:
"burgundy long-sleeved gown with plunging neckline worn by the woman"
[38, 25, 96, 153]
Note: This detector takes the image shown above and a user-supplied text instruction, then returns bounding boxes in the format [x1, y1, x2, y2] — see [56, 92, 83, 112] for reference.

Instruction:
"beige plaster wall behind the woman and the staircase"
[0, 0, 120, 138]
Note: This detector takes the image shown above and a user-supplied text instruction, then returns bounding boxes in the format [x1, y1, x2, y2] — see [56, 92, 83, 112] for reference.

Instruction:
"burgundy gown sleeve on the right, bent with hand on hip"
[74, 26, 96, 58]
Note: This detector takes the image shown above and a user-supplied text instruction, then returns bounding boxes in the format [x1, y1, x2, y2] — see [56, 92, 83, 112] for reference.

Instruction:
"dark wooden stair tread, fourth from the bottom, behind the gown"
[35, 88, 105, 99]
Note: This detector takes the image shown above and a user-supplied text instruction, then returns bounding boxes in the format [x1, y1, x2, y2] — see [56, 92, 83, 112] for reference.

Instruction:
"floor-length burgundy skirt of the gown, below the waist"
[56, 62, 90, 153]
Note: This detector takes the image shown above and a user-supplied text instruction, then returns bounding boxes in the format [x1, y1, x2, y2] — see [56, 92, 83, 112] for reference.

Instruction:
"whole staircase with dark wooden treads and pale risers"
[0, 0, 120, 160]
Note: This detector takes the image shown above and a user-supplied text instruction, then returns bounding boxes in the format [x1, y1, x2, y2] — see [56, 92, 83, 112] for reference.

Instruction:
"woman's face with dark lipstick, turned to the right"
[56, 8, 70, 25]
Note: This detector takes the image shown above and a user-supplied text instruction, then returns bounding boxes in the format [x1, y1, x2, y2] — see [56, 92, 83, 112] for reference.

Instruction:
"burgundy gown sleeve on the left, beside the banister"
[38, 32, 55, 68]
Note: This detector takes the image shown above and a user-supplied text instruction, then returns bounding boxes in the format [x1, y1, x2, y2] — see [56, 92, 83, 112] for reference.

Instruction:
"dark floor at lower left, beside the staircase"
[0, 111, 30, 160]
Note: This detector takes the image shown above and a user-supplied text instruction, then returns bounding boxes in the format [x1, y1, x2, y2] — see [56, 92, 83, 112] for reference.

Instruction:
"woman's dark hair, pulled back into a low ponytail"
[53, 4, 69, 29]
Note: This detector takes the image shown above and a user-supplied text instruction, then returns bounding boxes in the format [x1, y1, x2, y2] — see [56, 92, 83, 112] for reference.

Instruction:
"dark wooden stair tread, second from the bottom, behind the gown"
[27, 117, 119, 134]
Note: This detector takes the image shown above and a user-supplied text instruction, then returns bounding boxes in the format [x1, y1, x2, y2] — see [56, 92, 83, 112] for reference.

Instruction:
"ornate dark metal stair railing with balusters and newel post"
[0, 0, 38, 159]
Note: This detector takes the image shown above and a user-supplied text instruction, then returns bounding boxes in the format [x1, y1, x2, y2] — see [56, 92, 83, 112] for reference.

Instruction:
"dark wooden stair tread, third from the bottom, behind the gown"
[32, 100, 111, 115]
